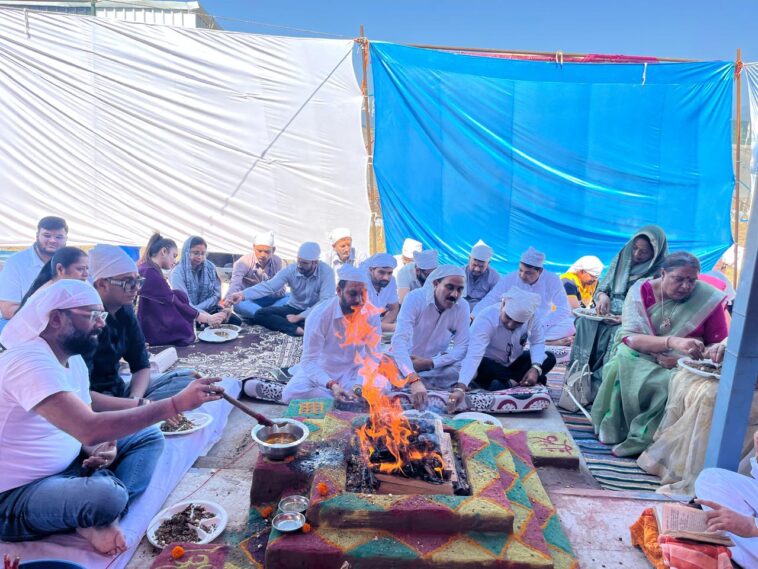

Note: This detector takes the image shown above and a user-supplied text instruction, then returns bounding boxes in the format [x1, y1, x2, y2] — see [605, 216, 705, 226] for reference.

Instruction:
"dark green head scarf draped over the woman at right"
[596, 225, 668, 314]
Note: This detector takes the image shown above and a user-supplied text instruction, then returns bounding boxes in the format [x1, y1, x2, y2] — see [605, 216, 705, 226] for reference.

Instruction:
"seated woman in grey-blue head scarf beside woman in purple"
[169, 236, 242, 324]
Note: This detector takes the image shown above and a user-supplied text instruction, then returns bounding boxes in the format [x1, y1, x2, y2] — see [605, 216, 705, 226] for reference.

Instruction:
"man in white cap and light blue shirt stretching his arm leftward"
[226, 242, 335, 336]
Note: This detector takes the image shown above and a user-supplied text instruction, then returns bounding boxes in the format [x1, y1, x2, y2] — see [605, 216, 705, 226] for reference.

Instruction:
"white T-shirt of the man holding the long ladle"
[0, 338, 92, 492]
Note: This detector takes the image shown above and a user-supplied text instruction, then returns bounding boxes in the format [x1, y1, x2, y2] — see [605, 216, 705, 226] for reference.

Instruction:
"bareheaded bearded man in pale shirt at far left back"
[0, 216, 68, 330]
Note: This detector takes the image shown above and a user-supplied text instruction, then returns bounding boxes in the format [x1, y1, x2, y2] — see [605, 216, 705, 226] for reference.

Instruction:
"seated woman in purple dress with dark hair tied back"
[137, 233, 225, 346]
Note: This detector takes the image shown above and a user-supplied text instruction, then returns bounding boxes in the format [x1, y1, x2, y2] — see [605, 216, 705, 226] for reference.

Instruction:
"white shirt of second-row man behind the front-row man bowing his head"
[473, 271, 574, 336]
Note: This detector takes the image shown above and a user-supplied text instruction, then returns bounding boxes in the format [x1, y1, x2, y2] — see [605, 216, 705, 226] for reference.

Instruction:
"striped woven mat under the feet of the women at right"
[547, 366, 661, 492]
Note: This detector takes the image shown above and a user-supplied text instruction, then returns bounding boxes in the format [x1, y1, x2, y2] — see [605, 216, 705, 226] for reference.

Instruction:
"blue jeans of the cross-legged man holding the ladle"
[0, 426, 164, 541]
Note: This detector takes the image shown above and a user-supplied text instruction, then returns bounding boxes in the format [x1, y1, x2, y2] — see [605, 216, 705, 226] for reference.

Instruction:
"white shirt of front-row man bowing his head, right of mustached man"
[458, 304, 545, 385]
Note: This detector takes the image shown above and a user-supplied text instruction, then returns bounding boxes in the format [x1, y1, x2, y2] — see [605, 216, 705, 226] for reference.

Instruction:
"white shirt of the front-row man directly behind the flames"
[292, 296, 382, 389]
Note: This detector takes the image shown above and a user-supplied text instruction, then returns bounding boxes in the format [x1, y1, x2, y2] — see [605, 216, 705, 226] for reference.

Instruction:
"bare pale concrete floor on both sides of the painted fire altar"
[128, 396, 661, 569]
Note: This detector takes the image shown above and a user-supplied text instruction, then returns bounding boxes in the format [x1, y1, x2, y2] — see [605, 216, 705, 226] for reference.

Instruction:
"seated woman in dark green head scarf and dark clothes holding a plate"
[567, 225, 668, 401]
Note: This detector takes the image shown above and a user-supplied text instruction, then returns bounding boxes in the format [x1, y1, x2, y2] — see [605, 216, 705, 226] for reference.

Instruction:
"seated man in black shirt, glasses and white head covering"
[84, 245, 196, 402]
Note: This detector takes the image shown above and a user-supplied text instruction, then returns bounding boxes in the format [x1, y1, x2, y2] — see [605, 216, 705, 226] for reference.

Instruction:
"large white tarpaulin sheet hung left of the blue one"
[0, 9, 370, 258]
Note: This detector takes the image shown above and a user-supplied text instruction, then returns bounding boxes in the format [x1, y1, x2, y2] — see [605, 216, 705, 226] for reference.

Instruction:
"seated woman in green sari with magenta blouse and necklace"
[592, 252, 728, 456]
